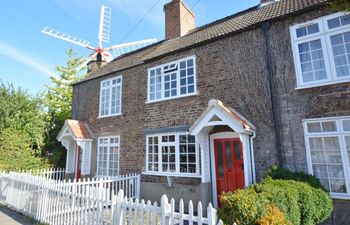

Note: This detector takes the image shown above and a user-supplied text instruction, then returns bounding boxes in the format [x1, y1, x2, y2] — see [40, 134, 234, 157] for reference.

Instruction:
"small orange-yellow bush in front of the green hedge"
[257, 204, 292, 225]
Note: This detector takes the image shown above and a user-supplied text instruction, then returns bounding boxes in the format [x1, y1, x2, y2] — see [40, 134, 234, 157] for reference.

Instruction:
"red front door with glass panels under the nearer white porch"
[214, 138, 244, 206]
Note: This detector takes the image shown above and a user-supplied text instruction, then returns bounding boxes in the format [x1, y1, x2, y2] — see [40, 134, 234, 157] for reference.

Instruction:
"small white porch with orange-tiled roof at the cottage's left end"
[57, 120, 93, 175]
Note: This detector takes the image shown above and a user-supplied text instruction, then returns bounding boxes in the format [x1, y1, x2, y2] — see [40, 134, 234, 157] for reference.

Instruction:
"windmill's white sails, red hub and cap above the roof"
[41, 5, 157, 71]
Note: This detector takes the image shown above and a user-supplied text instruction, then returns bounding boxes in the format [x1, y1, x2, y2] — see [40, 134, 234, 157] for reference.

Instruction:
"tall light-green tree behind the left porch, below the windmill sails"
[44, 49, 86, 167]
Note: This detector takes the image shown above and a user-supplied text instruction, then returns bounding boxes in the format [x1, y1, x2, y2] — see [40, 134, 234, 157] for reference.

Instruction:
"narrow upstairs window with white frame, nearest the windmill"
[100, 76, 122, 117]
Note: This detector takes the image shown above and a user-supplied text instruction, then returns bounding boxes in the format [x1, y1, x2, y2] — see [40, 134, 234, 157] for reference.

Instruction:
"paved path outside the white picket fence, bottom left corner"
[0, 204, 36, 225]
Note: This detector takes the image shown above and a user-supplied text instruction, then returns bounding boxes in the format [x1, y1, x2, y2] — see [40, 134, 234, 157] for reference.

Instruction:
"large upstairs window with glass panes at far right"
[290, 13, 350, 88]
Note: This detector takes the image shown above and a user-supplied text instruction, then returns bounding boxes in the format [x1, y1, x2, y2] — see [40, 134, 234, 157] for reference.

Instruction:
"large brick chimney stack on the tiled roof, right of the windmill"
[164, 0, 195, 40]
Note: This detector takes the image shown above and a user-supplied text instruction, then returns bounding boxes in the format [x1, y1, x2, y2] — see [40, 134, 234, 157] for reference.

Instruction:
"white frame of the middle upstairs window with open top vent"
[146, 55, 197, 104]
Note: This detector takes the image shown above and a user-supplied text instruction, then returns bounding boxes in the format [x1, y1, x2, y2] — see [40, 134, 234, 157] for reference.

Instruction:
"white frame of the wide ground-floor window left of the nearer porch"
[143, 132, 201, 178]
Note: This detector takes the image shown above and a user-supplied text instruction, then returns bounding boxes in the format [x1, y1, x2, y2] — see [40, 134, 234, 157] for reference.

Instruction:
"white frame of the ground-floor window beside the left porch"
[95, 135, 121, 177]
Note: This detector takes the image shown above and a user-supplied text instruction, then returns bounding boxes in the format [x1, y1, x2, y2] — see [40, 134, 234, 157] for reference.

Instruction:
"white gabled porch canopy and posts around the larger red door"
[190, 99, 255, 186]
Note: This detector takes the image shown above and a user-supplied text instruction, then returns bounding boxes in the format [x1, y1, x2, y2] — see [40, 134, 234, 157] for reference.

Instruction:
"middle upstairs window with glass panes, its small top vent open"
[148, 57, 196, 102]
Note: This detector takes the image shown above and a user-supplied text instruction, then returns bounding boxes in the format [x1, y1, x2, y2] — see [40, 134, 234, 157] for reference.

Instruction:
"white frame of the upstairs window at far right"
[289, 12, 350, 89]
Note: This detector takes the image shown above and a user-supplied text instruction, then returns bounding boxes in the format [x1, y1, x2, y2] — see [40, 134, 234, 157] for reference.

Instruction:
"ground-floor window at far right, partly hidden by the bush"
[304, 117, 350, 198]
